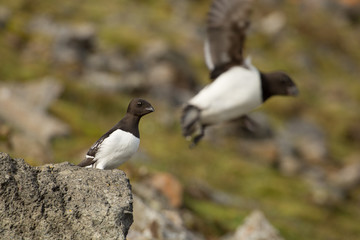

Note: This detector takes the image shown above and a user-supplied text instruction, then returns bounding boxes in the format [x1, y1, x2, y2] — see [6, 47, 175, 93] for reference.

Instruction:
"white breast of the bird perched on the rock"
[94, 129, 140, 169]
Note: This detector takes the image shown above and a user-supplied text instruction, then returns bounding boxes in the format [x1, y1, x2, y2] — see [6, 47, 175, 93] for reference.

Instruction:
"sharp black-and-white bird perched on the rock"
[78, 98, 154, 169]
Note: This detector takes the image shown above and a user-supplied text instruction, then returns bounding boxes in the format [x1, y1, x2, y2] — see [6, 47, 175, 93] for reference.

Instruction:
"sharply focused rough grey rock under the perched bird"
[0, 153, 133, 240]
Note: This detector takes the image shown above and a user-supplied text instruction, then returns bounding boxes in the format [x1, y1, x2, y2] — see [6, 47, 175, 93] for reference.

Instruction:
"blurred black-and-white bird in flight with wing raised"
[181, 0, 298, 146]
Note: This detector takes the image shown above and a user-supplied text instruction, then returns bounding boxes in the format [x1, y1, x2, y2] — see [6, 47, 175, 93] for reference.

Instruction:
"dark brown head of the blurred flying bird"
[261, 72, 299, 101]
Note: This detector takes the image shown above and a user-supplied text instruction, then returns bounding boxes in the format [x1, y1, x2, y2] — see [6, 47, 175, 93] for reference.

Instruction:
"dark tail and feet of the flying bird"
[181, 105, 204, 147]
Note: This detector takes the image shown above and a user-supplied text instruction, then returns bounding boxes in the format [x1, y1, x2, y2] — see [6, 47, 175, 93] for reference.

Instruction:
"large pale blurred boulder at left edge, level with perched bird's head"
[0, 78, 69, 146]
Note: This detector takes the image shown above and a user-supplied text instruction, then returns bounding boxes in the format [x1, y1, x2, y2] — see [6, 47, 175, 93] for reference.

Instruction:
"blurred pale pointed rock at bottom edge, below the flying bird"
[222, 210, 283, 240]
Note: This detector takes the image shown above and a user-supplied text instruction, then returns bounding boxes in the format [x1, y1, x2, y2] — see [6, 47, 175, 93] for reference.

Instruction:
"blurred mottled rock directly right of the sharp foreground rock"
[127, 178, 204, 240]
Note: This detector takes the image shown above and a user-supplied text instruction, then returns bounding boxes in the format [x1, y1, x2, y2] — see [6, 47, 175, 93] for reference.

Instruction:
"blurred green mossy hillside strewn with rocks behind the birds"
[0, 0, 360, 240]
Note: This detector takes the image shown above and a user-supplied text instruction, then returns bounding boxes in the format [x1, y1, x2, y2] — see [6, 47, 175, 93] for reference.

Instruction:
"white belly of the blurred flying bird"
[189, 66, 262, 124]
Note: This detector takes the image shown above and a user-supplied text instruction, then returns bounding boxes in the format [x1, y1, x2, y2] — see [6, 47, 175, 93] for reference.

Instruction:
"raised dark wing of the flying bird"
[204, 0, 252, 79]
